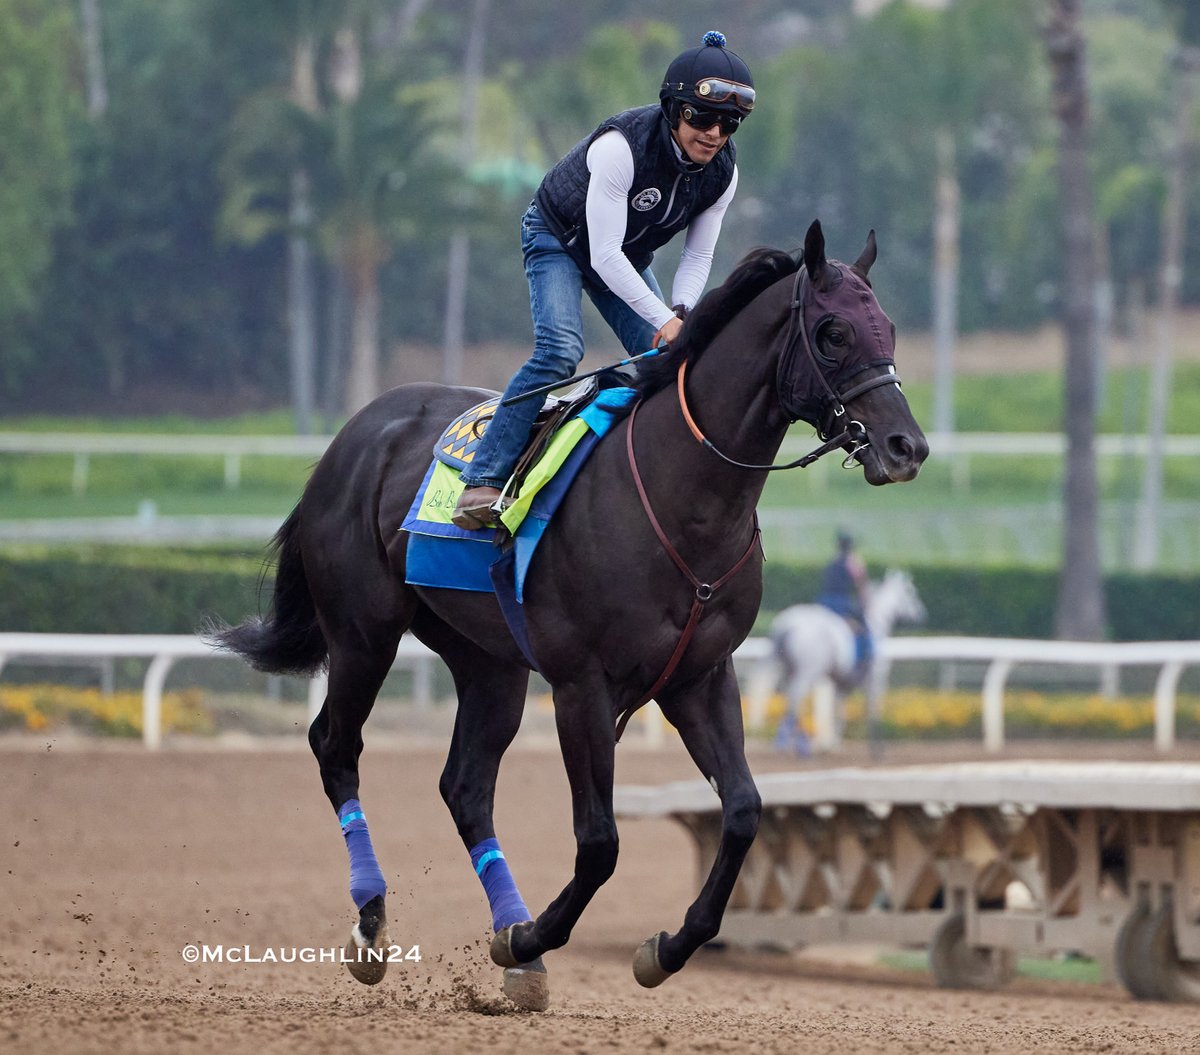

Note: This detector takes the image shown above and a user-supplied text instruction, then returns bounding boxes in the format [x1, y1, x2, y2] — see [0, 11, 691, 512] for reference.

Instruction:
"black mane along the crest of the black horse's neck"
[634, 246, 800, 398]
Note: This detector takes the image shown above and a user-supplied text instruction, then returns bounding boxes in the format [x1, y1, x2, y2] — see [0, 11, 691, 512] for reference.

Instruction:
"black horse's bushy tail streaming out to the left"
[203, 506, 329, 676]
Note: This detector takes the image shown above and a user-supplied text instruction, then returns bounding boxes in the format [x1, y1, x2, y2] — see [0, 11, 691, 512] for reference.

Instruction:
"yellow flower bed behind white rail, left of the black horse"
[0, 685, 212, 737]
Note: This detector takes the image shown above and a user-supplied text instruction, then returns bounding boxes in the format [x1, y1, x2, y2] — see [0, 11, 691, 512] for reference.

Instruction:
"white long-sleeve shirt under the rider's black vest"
[587, 128, 738, 326]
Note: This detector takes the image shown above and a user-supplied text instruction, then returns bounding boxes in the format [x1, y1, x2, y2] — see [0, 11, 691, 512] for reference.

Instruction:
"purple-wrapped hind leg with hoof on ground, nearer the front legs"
[413, 617, 550, 1011]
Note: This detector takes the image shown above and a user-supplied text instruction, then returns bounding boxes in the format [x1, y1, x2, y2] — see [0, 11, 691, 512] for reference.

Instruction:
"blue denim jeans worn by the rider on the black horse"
[462, 205, 662, 487]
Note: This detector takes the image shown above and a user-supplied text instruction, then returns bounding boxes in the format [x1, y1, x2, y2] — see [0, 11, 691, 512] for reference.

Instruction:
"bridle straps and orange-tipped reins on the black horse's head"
[676, 268, 900, 473]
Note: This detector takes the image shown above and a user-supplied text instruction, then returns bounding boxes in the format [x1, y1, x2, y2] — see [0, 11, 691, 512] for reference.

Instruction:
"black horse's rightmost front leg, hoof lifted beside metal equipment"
[634, 659, 762, 987]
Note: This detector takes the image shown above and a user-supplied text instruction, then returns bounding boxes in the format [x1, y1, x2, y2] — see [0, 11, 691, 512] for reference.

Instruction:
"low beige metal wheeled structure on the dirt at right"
[616, 762, 1200, 1001]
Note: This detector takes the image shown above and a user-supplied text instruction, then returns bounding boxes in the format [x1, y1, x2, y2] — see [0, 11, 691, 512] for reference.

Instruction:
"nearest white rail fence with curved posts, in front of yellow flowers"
[0, 634, 1200, 751]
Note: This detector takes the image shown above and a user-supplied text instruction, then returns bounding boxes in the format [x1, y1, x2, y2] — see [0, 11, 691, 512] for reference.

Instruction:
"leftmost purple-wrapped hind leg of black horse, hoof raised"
[308, 621, 404, 985]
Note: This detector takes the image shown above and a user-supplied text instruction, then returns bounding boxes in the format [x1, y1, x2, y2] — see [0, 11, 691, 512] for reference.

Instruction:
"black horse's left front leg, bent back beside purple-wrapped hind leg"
[492, 678, 617, 967]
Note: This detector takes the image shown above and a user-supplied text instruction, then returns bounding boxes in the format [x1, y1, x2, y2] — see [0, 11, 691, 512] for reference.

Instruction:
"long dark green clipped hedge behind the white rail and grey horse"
[0, 546, 1200, 641]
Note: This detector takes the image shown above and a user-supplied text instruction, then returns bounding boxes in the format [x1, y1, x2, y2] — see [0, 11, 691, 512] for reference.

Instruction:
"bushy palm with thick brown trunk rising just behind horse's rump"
[223, 11, 467, 413]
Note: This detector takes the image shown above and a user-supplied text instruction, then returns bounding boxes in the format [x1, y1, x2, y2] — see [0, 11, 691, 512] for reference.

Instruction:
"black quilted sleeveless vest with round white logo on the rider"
[534, 103, 737, 288]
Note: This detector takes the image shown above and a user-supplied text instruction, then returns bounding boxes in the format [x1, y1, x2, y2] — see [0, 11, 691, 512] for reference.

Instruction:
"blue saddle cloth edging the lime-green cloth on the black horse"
[401, 388, 637, 670]
